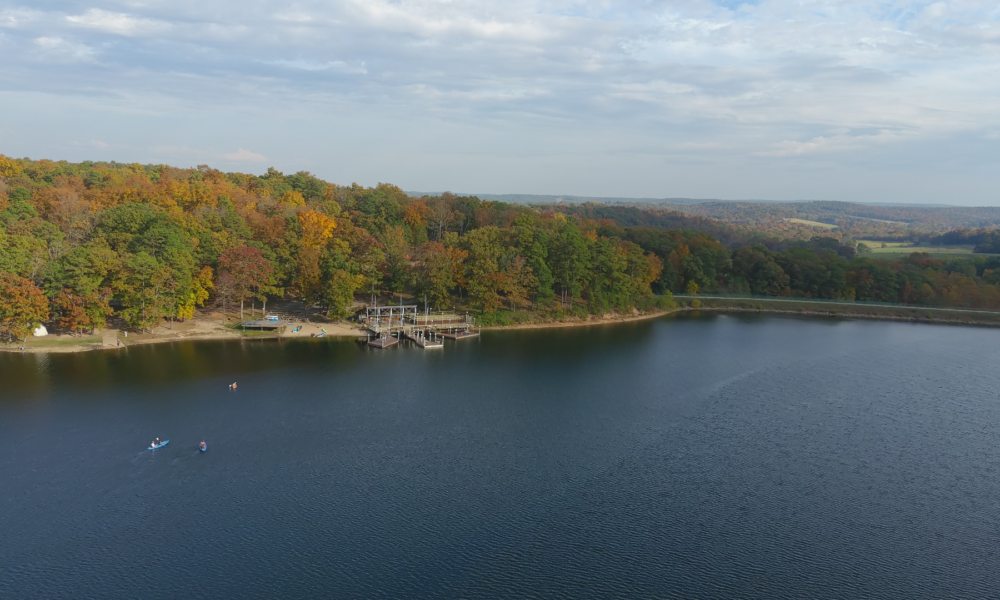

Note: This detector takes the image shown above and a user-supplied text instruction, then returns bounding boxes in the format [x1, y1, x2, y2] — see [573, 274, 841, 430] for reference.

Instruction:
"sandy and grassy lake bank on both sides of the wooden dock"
[0, 297, 1000, 353]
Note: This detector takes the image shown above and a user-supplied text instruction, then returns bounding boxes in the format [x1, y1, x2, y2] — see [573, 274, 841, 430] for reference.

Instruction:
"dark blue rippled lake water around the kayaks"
[0, 315, 1000, 599]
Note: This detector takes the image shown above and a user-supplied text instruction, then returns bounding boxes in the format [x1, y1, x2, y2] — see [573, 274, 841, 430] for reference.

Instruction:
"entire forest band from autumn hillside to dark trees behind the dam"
[0, 155, 1000, 339]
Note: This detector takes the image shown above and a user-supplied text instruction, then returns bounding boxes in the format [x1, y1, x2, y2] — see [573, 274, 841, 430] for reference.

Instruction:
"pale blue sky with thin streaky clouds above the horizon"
[0, 0, 1000, 205]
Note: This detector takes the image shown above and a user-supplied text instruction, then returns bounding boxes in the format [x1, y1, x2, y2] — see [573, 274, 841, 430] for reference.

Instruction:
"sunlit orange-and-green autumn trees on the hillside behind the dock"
[0, 157, 662, 337]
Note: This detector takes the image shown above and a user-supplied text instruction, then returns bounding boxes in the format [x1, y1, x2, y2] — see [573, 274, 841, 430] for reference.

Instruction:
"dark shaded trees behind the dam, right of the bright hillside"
[599, 226, 1000, 309]
